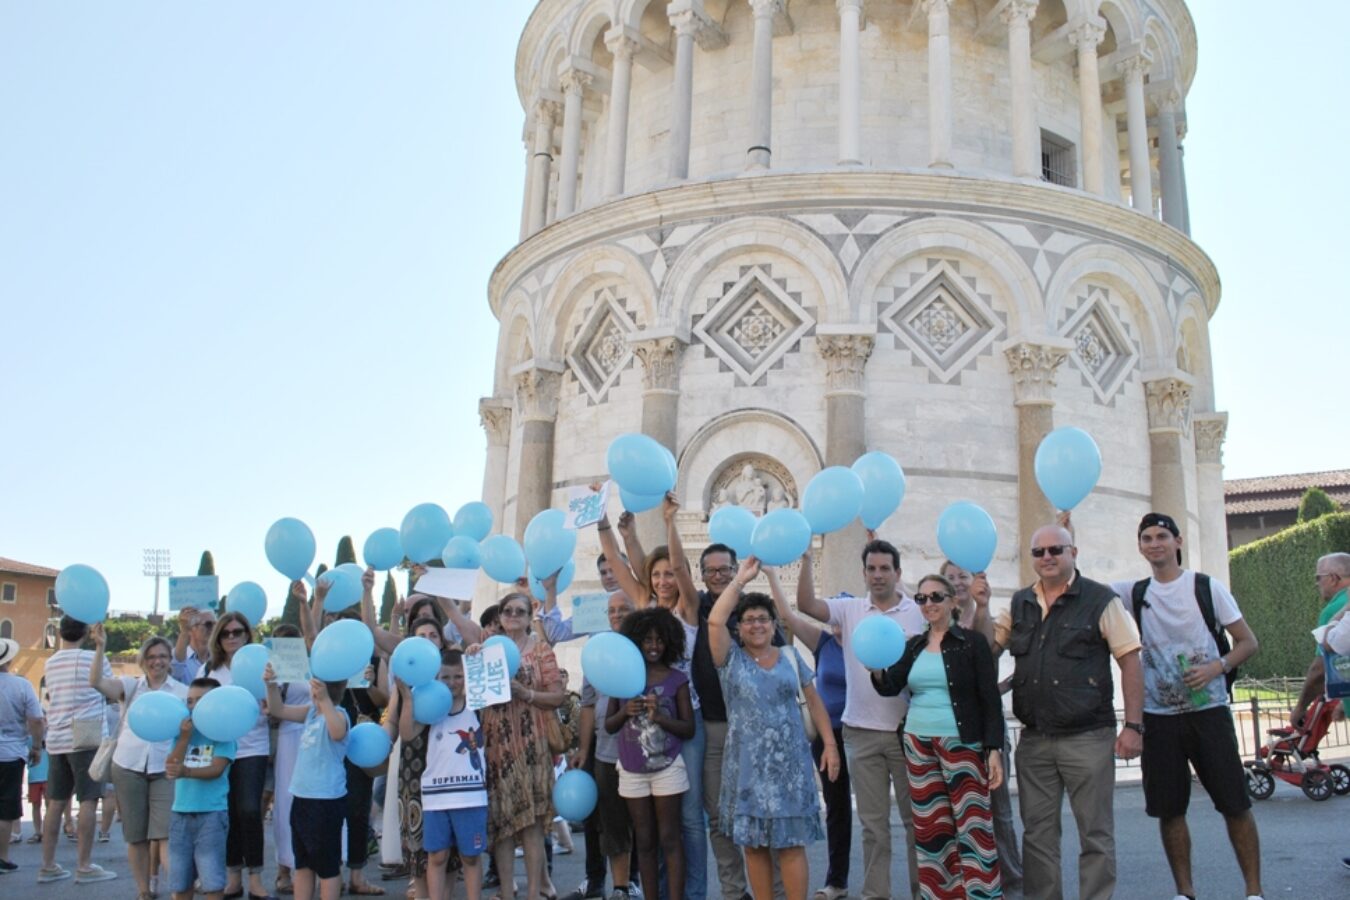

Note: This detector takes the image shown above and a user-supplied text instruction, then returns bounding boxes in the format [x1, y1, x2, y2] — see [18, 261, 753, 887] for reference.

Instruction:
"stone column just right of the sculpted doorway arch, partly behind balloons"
[815, 327, 876, 595]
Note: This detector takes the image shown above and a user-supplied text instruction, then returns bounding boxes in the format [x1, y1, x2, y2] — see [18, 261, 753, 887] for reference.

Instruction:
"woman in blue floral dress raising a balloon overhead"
[707, 556, 840, 900]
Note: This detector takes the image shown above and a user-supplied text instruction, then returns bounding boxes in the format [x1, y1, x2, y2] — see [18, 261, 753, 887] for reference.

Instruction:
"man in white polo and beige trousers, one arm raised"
[797, 538, 923, 900]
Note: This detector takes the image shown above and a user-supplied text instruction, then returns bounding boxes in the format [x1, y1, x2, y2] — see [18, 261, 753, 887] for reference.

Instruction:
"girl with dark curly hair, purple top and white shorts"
[605, 606, 697, 897]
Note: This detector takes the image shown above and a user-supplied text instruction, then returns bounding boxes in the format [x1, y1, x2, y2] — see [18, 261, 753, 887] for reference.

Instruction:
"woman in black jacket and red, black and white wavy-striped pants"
[872, 575, 1003, 900]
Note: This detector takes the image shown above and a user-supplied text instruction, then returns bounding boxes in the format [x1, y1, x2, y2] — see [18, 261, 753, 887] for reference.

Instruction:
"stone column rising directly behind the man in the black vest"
[1003, 341, 1069, 584]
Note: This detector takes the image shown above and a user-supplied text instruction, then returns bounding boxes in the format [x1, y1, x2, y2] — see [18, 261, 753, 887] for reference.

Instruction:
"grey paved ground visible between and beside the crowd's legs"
[0, 783, 1350, 900]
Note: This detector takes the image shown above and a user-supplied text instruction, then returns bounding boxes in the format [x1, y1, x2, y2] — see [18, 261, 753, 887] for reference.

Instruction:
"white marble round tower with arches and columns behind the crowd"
[481, 0, 1227, 604]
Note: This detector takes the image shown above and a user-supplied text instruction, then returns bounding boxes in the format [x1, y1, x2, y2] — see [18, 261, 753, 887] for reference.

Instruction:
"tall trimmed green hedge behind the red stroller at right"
[1229, 513, 1350, 679]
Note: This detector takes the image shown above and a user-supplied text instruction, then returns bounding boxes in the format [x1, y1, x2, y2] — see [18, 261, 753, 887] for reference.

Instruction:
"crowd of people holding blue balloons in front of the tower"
[0, 495, 1328, 900]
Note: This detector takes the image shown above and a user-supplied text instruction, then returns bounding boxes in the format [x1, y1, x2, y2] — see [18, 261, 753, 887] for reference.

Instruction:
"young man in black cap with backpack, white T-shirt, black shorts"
[1111, 513, 1261, 900]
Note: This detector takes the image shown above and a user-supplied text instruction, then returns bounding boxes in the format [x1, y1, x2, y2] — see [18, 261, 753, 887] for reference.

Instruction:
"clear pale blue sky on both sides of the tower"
[0, 0, 1350, 614]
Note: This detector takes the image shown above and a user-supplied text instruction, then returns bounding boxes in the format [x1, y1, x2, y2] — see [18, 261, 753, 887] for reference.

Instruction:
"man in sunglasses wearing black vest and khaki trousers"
[976, 525, 1143, 900]
